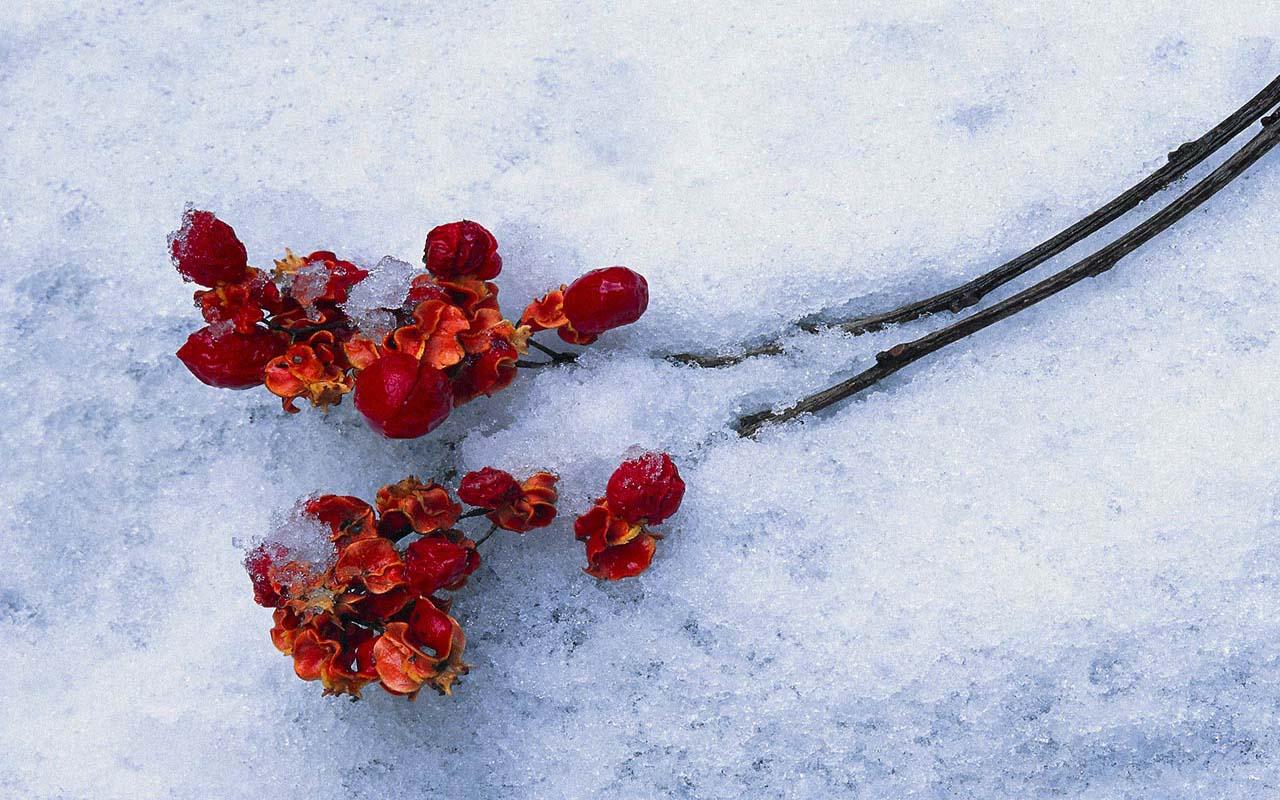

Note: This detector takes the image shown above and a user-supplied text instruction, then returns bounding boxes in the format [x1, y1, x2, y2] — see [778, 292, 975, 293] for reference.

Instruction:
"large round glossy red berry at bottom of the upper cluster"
[356, 351, 453, 439]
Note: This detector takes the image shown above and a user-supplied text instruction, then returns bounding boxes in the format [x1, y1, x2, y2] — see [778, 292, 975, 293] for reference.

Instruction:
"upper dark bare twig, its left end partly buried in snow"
[667, 77, 1280, 367]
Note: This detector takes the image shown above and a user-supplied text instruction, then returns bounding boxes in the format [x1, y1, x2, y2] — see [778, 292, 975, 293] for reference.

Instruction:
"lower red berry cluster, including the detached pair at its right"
[244, 453, 685, 699]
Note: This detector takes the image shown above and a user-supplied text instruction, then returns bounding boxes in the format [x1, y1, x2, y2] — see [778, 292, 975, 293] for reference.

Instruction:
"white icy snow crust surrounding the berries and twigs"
[0, 1, 1280, 800]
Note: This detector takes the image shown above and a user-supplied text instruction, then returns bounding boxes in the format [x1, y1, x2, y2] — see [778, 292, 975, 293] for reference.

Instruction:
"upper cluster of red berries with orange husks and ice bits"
[170, 210, 649, 439]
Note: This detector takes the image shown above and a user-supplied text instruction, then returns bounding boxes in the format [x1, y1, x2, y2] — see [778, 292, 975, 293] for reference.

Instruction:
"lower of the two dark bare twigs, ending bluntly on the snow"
[737, 114, 1280, 436]
